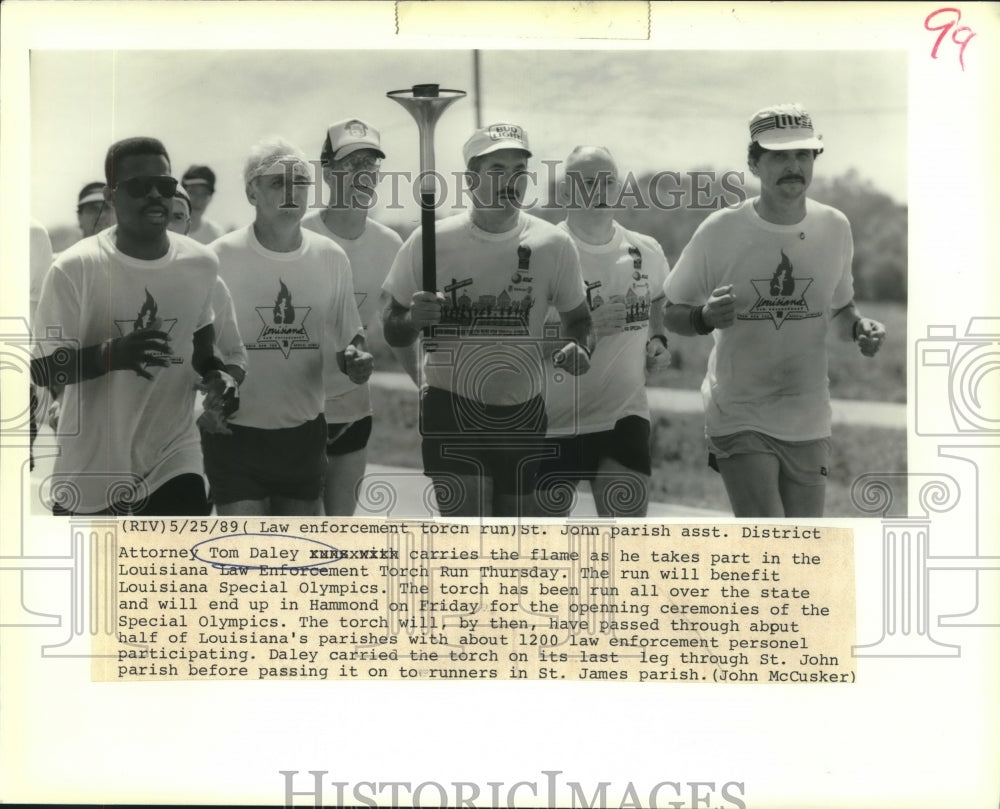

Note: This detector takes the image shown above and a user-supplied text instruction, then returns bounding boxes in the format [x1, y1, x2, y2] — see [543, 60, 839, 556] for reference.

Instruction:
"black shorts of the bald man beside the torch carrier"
[538, 416, 653, 488]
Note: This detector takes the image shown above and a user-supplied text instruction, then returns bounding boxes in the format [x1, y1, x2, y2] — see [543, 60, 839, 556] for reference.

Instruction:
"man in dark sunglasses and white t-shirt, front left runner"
[31, 137, 235, 516]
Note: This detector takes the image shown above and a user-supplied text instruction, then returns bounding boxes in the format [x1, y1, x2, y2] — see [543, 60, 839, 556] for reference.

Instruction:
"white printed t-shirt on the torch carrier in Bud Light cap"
[382, 213, 585, 405]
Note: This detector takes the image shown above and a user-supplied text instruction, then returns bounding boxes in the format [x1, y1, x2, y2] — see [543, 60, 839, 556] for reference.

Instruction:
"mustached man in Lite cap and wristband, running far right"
[664, 104, 885, 518]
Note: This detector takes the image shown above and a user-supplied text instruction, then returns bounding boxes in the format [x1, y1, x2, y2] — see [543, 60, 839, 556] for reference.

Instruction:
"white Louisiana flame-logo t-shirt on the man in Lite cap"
[664, 199, 854, 441]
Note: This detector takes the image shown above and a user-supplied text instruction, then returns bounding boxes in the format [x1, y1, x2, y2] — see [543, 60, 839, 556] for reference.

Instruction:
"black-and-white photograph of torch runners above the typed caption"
[30, 48, 908, 518]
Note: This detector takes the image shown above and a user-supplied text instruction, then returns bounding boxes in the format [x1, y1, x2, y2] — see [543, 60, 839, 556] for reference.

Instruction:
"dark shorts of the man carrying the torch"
[420, 388, 547, 494]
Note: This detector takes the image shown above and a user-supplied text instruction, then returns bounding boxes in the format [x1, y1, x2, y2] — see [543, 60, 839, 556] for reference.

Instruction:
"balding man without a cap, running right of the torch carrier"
[537, 146, 670, 517]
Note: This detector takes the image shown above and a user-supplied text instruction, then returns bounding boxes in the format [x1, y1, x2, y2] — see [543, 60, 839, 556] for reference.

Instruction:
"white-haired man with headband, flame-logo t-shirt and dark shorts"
[202, 139, 372, 516]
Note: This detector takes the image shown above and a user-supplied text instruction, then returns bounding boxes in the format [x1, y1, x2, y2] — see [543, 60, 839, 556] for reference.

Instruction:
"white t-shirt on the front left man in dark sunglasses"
[34, 226, 218, 512]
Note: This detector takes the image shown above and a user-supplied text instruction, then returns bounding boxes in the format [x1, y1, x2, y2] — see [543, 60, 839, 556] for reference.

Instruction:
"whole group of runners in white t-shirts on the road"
[32, 105, 885, 517]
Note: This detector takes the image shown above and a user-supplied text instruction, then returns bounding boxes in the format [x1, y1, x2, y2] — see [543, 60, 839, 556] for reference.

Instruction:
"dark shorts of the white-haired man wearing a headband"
[201, 413, 326, 504]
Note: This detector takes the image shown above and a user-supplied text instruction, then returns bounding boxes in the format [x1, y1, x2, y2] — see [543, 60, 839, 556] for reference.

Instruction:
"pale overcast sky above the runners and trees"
[31, 50, 907, 228]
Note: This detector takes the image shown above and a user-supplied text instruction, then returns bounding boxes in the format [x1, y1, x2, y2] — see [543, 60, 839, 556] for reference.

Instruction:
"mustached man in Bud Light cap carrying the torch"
[383, 123, 592, 517]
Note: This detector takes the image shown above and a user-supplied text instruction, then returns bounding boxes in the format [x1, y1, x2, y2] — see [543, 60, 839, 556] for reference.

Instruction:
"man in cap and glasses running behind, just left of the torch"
[302, 118, 417, 517]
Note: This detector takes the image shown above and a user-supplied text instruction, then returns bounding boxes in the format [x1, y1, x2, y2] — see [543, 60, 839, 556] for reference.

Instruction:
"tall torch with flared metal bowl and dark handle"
[386, 84, 465, 337]
